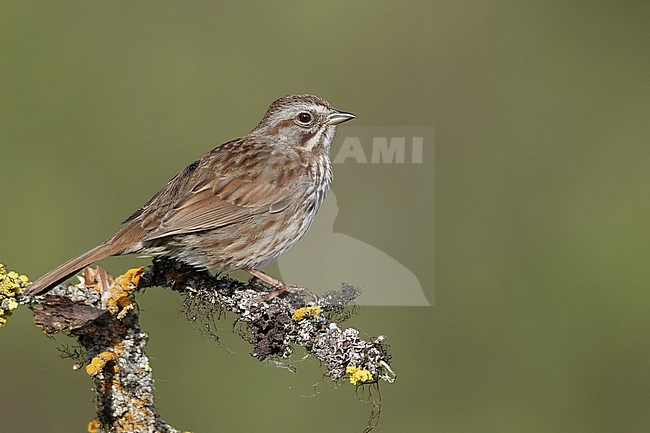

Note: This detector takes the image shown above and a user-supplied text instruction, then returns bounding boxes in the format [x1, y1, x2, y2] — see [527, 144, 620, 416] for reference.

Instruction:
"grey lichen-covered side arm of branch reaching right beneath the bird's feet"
[140, 260, 394, 383]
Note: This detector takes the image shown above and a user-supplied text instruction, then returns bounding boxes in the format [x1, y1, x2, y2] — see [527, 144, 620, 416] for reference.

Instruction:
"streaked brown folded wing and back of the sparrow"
[142, 136, 301, 240]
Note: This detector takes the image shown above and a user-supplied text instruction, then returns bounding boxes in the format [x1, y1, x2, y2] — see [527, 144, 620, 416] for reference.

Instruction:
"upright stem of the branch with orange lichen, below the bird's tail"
[32, 268, 178, 433]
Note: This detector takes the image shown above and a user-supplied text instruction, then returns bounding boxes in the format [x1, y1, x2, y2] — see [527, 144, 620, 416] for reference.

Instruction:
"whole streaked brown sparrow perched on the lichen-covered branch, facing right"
[25, 95, 355, 295]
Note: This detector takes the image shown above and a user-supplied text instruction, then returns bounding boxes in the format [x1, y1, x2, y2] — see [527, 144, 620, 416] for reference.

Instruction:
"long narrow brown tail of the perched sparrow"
[24, 243, 124, 296]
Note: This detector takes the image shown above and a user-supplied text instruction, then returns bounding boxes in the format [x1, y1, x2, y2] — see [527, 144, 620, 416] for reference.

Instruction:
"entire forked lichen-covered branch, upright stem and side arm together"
[5, 259, 395, 433]
